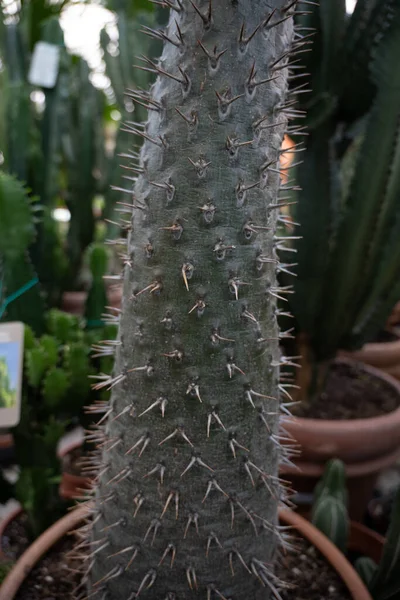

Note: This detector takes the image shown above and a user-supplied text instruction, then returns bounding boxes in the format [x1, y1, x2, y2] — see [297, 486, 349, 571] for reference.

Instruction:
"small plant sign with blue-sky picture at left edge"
[0, 322, 24, 429]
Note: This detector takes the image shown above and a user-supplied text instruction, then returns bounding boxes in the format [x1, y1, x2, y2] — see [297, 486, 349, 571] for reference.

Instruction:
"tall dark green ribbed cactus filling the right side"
[281, 0, 400, 399]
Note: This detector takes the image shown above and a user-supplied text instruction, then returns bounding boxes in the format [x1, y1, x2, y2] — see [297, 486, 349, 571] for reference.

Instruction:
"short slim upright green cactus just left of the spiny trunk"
[85, 244, 109, 327]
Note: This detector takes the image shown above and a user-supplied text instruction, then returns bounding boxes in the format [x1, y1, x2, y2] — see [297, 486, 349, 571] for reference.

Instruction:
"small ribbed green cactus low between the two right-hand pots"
[311, 459, 349, 552]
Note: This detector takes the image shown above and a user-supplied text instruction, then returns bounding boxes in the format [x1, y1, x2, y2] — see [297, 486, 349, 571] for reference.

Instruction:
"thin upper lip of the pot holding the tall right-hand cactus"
[287, 358, 400, 434]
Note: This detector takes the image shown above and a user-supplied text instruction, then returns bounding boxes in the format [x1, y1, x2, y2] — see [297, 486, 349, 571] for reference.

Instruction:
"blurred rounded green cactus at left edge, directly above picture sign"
[0, 172, 44, 333]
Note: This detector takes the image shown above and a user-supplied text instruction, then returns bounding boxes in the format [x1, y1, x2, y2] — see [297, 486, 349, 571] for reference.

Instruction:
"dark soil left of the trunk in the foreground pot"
[15, 536, 81, 600]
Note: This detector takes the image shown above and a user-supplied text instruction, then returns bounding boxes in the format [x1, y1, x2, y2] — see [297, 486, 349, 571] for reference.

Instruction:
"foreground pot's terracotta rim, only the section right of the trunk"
[280, 509, 372, 600]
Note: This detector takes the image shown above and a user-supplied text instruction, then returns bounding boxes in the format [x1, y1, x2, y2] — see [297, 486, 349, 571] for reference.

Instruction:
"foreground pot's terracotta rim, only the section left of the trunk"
[0, 507, 87, 600]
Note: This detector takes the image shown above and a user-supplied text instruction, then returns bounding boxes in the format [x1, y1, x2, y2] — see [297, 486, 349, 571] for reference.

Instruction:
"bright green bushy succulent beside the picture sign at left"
[7, 309, 115, 539]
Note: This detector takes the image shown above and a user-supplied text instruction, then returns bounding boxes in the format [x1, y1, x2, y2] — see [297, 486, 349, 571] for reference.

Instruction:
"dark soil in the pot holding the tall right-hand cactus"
[293, 363, 400, 420]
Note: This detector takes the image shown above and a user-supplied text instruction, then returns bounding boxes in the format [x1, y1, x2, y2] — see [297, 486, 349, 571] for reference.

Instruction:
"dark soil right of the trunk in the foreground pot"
[276, 538, 351, 600]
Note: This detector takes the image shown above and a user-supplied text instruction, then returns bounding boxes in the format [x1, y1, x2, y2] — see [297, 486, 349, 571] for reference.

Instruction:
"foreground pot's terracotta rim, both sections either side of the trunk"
[0, 506, 372, 600]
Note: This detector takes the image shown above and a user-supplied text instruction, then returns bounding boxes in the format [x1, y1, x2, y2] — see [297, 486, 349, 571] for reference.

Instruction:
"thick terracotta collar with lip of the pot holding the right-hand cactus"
[285, 358, 400, 464]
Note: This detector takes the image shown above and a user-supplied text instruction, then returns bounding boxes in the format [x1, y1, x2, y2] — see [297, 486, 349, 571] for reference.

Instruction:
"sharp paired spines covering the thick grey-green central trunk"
[69, 0, 310, 600]
